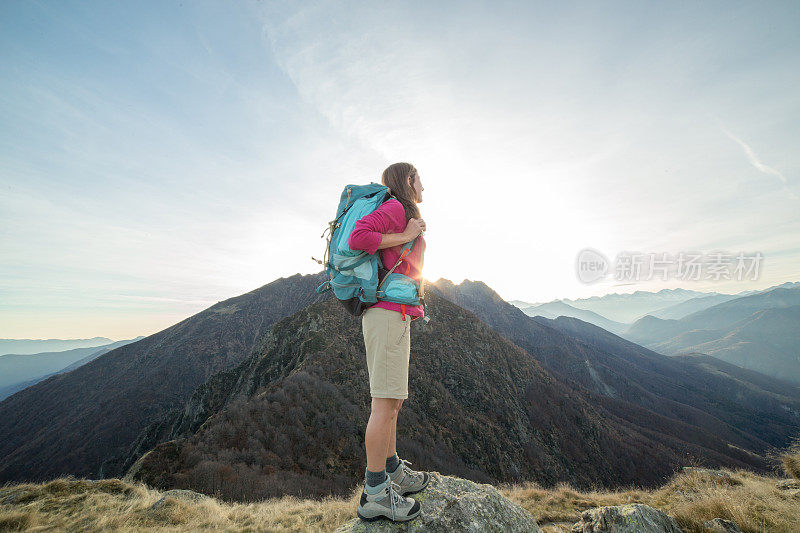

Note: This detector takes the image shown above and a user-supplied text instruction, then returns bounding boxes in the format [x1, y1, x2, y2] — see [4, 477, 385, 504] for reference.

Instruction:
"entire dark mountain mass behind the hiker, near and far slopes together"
[0, 272, 800, 499]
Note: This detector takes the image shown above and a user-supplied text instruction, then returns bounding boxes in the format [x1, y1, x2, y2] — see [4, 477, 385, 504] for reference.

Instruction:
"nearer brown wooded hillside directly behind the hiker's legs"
[131, 293, 764, 501]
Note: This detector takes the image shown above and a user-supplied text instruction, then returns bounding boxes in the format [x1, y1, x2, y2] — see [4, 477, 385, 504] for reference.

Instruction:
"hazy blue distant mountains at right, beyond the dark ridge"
[517, 282, 800, 383]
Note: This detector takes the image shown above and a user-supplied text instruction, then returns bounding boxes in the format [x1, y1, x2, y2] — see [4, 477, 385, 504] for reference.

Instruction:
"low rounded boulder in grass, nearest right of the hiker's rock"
[572, 503, 682, 533]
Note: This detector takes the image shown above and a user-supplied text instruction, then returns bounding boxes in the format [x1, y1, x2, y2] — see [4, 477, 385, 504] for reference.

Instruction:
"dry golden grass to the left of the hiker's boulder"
[0, 478, 360, 532]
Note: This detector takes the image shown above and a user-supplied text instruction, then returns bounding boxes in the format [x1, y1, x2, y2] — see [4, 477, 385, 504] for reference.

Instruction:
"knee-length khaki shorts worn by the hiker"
[361, 307, 411, 398]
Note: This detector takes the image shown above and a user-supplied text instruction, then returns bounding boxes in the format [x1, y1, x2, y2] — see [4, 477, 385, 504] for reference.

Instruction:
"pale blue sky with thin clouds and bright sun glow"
[0, 1, 800, 340]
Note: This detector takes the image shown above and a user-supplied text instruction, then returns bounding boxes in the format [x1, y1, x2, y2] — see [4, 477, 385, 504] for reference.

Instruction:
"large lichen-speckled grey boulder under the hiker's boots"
[336, 472, 542, 533]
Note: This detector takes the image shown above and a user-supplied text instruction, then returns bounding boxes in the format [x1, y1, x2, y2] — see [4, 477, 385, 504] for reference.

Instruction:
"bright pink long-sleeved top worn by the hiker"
[347, 198, 425, 320]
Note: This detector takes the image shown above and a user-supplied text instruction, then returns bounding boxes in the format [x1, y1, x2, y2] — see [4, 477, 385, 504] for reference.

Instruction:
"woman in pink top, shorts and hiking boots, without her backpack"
[348, 163, 429, 522]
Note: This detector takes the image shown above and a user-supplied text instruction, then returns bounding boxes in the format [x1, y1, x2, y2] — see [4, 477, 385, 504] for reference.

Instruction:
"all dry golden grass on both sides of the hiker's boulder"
[0, 470, 800, 533]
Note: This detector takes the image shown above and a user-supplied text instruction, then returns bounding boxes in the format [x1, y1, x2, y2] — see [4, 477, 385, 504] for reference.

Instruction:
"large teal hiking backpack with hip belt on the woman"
[311, 183, 429, 322]
